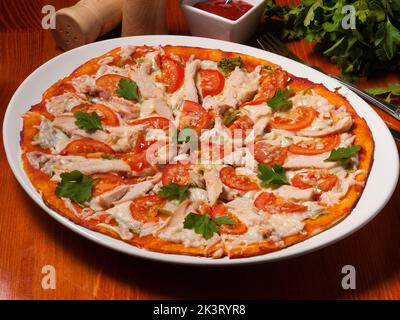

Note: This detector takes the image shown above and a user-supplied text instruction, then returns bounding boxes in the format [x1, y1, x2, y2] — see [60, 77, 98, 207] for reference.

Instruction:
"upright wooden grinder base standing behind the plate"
[122, 0, 168, 37]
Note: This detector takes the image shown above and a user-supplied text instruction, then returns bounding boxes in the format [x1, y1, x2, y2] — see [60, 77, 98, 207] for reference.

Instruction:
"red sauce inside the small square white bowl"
[194, 0, 253, 20]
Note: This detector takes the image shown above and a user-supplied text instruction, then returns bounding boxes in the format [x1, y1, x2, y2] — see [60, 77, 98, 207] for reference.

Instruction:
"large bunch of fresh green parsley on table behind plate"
[264, 0, 400, 81]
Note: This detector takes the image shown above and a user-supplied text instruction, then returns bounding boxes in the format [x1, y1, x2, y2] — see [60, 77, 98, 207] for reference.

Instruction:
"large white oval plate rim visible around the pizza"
[3, 36, 399, 265]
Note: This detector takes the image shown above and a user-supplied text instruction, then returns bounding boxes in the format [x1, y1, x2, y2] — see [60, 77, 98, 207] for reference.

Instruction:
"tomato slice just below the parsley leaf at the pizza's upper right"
[270, 106, 317, 131]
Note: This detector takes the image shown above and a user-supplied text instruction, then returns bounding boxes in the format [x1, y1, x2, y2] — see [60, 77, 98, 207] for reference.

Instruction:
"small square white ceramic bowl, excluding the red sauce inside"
[181, 0, 265, 43]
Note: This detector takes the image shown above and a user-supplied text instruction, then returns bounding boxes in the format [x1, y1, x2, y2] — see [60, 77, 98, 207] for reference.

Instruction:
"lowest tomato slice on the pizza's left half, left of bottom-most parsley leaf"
[130, 195, 166, 223]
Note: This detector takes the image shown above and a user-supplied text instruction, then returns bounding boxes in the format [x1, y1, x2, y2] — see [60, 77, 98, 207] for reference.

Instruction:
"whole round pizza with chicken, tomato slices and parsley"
[21, 45, 374, 258]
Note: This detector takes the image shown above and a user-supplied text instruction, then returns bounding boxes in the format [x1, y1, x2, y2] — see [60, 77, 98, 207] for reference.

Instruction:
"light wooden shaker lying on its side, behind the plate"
[53, 0, 123, 50]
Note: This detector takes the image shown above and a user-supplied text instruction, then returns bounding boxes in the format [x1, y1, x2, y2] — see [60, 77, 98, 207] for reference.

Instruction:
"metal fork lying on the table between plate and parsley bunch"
[257, 32, 400, 120]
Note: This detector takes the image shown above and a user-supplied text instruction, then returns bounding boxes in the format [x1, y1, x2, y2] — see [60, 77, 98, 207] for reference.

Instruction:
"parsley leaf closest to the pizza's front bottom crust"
[183, 212, 236, 240]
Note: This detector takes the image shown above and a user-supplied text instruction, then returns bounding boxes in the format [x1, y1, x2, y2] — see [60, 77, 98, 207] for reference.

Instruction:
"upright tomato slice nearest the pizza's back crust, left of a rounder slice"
[161, 56, 185, 93]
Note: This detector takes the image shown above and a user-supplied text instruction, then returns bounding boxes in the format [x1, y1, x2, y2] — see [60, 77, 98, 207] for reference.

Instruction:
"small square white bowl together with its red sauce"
[181, 0, 264, 43]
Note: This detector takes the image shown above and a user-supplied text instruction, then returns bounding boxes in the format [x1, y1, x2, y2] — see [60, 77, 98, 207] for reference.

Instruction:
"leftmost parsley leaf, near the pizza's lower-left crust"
[56, 170, 93, 203]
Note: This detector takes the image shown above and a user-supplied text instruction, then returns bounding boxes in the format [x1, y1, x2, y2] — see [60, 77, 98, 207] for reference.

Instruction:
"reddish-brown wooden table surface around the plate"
[0, 0, 400, 299]
